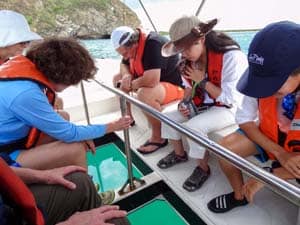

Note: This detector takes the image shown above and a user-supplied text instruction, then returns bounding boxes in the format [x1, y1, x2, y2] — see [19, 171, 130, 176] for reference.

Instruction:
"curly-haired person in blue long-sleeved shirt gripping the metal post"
[0, 38, 131, 169]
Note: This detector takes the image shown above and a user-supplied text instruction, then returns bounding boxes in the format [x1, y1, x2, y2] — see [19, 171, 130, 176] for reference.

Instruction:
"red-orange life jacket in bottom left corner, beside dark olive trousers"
[0, 157, 45, 225]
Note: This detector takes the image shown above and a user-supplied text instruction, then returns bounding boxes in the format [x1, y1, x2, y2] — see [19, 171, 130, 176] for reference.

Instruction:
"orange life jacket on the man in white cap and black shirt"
[129, 28, 148, 78]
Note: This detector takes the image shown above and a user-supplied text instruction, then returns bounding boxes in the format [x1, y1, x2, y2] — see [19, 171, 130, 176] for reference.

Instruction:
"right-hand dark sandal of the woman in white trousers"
[182, 166, 210, 192]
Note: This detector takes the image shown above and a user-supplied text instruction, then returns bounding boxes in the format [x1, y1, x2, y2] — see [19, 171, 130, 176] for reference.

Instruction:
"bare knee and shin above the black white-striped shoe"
[219, 133, 257, 200]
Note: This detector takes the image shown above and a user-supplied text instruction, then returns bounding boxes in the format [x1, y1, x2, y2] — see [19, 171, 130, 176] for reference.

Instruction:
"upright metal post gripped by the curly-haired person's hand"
[119, 96, 145, 195]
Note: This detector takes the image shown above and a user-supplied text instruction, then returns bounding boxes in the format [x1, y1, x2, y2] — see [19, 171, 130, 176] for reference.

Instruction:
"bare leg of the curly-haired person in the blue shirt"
[17, 141, 87, 169]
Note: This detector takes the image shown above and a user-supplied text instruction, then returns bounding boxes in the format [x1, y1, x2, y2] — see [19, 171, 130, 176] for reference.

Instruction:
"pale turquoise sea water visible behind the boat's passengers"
[82, 31, 256, 59]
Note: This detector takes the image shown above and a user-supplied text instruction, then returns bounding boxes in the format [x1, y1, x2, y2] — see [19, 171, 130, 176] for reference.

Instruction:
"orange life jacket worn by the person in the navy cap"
[258, 96, 300, 159]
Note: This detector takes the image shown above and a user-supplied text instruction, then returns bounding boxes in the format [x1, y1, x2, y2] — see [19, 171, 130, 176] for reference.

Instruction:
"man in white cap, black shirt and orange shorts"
[111, 26, 184, 154]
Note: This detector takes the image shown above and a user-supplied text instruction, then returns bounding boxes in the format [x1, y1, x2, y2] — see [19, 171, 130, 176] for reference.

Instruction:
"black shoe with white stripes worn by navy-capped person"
[207, 192, 248, 213]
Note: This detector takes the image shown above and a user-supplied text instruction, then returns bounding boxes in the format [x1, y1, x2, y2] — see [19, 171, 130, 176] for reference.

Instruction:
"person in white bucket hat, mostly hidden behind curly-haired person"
[0, 10, 70, 125]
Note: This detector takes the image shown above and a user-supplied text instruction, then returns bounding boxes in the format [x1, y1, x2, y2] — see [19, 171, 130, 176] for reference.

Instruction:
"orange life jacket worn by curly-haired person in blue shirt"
[0, 56, 55, 149]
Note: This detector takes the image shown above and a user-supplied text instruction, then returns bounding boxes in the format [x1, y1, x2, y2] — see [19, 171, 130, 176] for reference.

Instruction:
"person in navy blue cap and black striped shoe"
[208, 21, 300, 213]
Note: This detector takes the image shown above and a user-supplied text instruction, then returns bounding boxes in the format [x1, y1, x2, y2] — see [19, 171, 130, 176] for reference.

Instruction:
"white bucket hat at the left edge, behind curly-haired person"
[0, 10, 42, 47]
